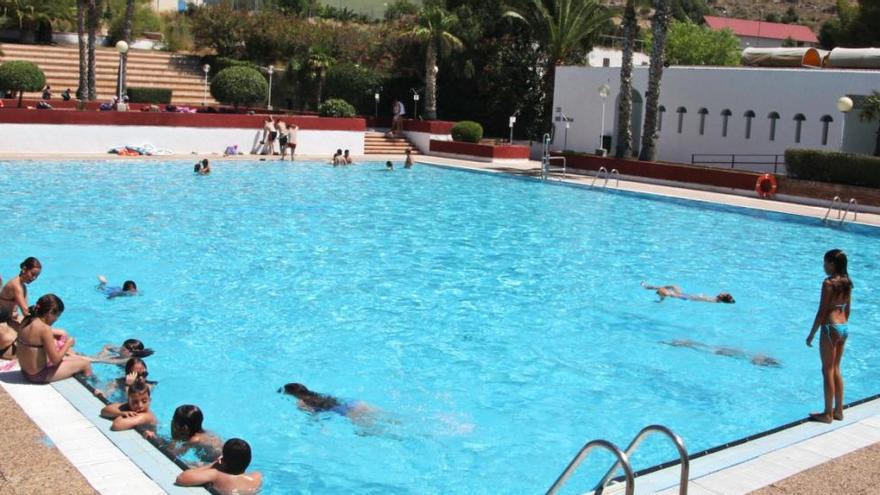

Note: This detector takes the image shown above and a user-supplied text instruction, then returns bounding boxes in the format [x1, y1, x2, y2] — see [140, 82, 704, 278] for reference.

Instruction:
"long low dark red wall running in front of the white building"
[554, 153, 761, 189]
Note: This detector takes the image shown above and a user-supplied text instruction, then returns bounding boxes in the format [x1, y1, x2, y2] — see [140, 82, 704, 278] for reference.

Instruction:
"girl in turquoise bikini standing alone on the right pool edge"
[807, 249, 853, 423]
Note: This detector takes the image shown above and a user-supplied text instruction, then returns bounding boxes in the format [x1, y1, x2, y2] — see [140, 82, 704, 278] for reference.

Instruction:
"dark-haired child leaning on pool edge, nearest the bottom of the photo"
[175, 438, 263, 495]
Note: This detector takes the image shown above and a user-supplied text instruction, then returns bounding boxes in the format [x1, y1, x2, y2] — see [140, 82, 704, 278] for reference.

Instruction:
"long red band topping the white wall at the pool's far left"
[0, 108, 366, 132]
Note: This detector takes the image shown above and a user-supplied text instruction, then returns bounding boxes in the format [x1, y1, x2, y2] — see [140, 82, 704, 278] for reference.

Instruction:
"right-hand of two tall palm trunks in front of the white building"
[639, 0, 669, 162]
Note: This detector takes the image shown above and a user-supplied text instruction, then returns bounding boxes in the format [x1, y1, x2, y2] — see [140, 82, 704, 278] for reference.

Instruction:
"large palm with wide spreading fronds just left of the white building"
[504, 0, 608, 134]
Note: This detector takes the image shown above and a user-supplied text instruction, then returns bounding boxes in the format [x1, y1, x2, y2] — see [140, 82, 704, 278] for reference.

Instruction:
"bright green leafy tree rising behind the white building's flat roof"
[649, 21, 740, 66]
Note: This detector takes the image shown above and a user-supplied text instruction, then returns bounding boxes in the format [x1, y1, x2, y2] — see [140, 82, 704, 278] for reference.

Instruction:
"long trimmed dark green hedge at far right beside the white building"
[785, 149, 880, 188]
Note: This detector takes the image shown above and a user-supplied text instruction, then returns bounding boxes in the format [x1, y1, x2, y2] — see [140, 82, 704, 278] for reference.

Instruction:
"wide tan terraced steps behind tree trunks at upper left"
[0, 43, 217, 105]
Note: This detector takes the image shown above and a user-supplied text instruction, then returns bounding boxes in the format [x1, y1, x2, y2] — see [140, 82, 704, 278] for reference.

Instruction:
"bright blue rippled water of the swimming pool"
[0, 161, 880, 494]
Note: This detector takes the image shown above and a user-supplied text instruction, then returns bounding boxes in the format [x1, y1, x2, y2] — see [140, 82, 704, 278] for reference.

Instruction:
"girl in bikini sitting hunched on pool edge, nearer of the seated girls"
[17, 294, 92, 383]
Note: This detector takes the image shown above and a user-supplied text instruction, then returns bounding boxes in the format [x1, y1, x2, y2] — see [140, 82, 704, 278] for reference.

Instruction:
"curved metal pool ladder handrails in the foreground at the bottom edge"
[546, 425, 690, 495]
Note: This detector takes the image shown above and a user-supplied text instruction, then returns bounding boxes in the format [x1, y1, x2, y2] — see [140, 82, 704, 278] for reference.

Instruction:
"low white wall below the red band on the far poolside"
[0, 124, 364, 156]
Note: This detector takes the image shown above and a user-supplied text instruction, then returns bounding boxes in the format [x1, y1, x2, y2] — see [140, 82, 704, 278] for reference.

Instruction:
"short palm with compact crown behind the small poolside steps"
[412, 7, 464, 120]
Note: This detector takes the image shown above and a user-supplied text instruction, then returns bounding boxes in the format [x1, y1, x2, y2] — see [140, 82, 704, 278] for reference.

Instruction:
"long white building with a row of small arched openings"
[553, 67, 880, 173]
